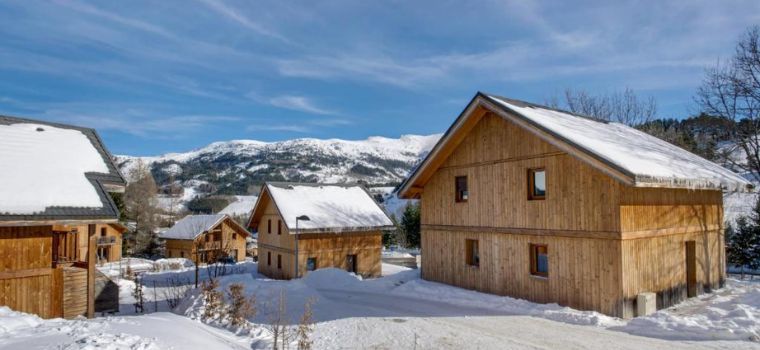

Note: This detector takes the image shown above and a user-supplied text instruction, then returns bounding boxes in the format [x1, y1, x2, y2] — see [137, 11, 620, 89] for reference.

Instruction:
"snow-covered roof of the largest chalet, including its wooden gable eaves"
[400, 93, 751, 197]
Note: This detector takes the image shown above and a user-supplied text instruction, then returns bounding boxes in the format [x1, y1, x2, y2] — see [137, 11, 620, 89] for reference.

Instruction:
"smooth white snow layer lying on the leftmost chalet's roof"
[0, 123, 109, 214]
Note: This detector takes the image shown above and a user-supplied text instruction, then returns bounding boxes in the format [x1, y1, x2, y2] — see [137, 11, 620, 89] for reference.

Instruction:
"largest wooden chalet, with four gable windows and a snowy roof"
[399, 93, 750, 317]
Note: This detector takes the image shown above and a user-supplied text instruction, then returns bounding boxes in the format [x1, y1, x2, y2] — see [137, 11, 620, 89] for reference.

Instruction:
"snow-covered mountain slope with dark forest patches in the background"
[116, 134, 441, 201]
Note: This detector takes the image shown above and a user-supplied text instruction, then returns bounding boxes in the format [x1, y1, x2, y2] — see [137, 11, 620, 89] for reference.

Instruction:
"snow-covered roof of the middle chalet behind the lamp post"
[257, 183, 393, 233]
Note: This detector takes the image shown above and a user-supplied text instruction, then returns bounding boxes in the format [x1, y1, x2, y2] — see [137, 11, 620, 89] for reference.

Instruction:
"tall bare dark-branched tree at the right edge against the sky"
[695, 26, 760, 181]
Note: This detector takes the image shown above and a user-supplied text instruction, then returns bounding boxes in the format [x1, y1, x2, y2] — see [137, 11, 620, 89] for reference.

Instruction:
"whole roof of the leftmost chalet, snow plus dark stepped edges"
[0, 116, 124, 221]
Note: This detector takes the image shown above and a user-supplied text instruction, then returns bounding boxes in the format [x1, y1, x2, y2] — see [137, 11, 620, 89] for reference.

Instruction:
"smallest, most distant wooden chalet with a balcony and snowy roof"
[159, 214, 249, 263]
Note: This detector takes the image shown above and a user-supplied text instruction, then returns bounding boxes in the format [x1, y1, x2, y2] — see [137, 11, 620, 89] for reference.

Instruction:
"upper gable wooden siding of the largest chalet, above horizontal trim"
[421, 114, 621, 238]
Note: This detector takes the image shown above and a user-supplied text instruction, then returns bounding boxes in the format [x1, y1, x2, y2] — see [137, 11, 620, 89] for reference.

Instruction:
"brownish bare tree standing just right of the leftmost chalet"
[124, 159, 158, 255]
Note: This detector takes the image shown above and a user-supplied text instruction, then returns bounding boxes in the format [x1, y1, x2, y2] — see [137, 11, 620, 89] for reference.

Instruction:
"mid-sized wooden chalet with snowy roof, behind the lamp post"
[248, 183, 393, 279]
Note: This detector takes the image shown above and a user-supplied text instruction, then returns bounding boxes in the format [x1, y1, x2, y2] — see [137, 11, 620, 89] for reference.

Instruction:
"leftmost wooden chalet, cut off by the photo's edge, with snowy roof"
[0, 116, 125, 318]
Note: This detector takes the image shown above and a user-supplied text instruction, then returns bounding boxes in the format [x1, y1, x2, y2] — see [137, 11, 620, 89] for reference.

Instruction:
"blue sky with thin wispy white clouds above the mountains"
[0, 0, 760, 155]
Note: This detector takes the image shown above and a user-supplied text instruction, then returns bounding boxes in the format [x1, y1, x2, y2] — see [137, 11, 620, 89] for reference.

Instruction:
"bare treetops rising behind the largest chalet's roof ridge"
[546, 88, 657, 126]
